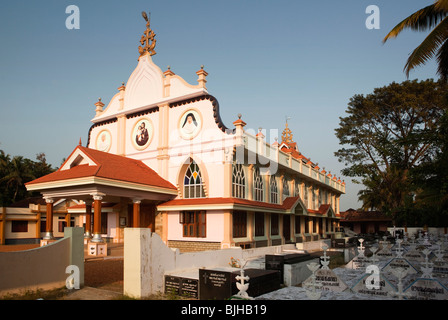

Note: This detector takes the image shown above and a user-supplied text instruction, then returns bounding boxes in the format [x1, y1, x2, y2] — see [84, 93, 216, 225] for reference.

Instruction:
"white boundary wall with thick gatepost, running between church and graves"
[124, 228, 296, 299]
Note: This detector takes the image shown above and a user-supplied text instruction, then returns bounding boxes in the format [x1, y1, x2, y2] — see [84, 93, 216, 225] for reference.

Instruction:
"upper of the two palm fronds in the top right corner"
[383, 0, 448, 43]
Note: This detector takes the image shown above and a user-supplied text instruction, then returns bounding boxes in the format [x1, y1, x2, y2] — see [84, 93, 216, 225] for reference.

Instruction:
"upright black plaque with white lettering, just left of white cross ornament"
[199, 269, 232, 300]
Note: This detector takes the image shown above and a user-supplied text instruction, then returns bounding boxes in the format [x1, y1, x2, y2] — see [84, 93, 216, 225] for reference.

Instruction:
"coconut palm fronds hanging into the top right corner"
[383, 0, 448, 81]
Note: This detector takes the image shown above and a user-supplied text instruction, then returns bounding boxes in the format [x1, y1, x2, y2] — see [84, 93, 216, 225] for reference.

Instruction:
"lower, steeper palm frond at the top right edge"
[404, 18, 448, 77]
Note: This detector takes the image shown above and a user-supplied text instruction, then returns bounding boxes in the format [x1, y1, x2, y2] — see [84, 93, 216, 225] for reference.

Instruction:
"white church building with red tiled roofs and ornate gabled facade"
[21, 12, 345, 251]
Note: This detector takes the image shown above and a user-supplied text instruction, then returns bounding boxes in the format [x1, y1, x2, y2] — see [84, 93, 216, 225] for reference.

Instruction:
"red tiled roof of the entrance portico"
[26, 146, 177, 190]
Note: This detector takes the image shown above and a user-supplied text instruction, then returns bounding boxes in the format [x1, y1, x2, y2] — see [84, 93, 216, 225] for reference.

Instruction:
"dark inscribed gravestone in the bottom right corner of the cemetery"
[405, 278, 448, 300]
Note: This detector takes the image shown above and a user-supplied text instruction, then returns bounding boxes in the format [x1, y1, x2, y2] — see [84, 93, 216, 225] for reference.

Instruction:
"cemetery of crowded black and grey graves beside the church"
[150, 231, 448, 300]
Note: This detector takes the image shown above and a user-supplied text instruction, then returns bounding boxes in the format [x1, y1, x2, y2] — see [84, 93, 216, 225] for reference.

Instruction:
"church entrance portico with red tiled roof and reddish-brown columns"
[27, 146, 177, 253]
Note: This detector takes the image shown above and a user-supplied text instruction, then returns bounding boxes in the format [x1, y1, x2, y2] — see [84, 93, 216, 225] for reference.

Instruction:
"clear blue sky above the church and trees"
[0, 0, 437, 210]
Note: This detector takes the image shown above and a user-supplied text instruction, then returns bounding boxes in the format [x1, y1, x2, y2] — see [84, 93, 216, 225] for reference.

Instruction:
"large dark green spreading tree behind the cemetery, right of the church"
[335, 79, 448, 221]
